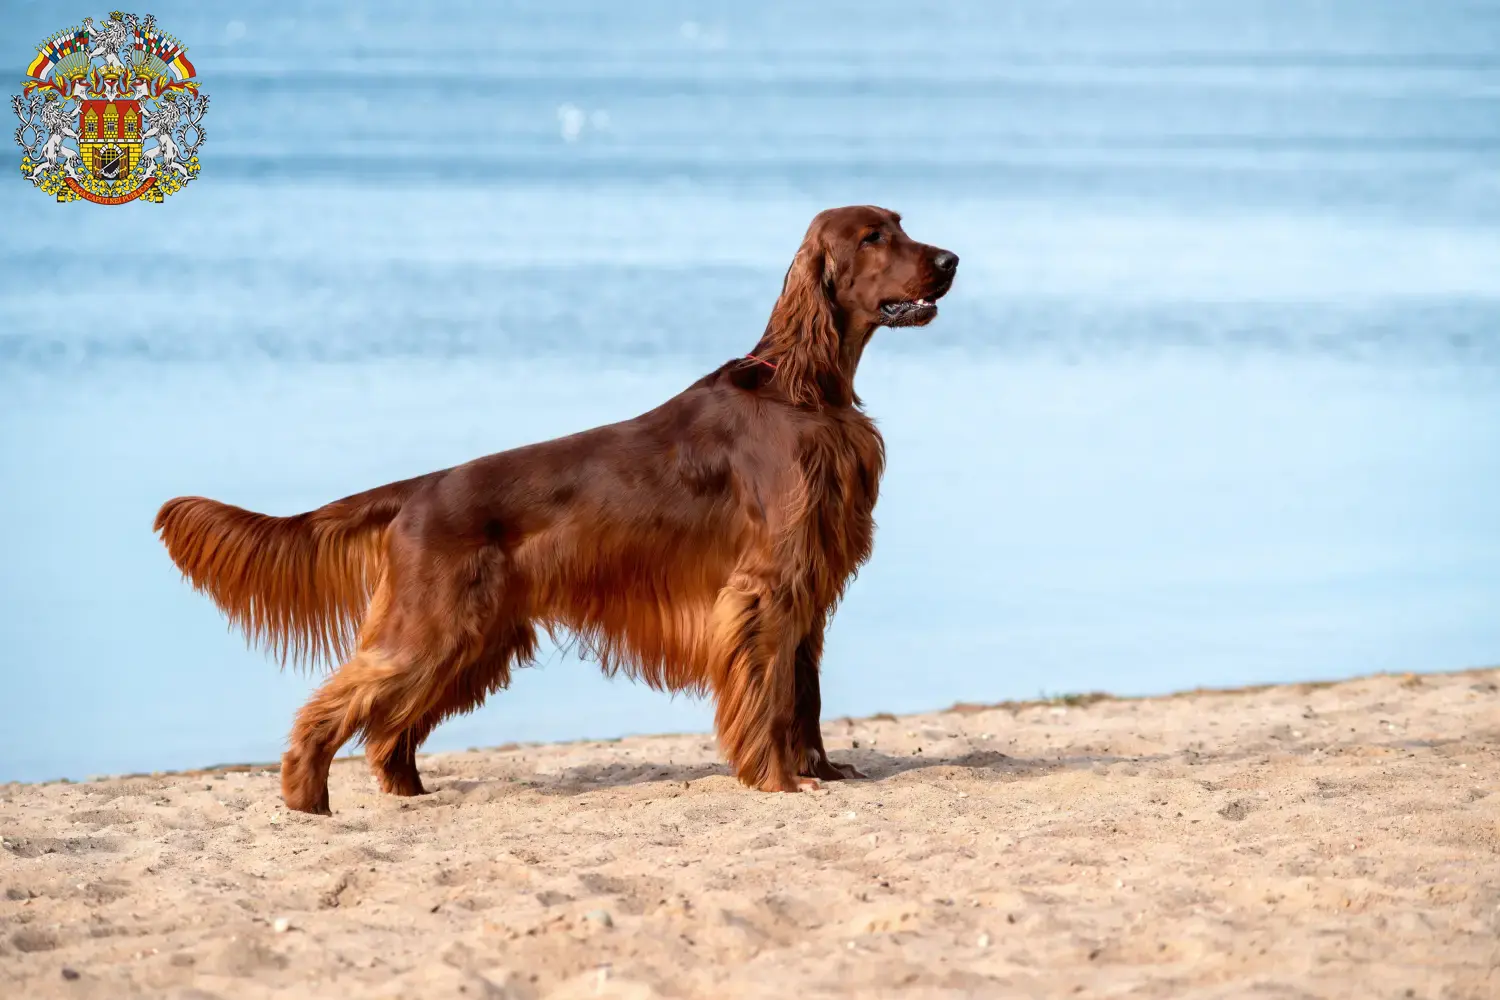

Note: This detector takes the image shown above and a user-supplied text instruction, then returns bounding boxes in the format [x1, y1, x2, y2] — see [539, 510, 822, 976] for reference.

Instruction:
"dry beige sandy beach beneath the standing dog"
[0, 670, 1500, 999]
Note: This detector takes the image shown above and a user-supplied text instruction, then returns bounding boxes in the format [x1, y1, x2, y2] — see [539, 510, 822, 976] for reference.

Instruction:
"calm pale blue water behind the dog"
[0, 0, 1500, 780]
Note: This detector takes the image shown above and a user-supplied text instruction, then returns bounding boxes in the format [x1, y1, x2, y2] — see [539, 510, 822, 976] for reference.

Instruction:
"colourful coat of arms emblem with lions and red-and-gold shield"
[11, 10, 209, 205]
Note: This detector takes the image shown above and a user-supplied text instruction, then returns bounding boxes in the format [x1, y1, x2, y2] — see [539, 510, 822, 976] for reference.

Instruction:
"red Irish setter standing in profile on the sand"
[156, 207, 959, 814]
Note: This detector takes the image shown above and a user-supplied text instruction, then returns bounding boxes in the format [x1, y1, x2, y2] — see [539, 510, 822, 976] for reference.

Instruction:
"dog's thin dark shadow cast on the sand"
[438, 750, 1170, 796]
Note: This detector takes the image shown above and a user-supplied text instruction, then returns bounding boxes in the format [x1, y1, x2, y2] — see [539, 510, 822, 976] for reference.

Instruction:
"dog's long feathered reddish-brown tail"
[155, 472, 440, 666]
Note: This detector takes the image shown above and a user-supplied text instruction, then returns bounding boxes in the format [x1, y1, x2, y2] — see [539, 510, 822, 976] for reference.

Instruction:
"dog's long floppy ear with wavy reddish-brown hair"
[758, 232, 843, 405]
